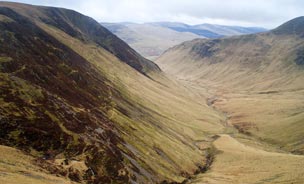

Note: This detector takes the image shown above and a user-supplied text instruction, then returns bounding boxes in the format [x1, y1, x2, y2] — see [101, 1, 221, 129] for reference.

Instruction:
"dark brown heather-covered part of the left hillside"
[0, 4, 134, 182]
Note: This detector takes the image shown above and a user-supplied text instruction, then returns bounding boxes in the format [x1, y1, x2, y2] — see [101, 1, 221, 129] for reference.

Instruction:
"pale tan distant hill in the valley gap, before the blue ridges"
[101, 23, 204, 59]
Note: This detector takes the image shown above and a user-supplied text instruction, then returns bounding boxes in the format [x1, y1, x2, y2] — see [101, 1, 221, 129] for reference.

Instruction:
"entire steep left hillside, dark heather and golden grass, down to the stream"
[0, 2, 224, 183]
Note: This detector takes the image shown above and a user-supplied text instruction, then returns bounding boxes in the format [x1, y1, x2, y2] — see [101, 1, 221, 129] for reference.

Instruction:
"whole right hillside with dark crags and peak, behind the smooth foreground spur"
[157, 17, 304, 154]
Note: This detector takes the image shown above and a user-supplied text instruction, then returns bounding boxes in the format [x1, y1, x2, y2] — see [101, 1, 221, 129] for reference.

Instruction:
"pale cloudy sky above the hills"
[4, 0, 304, 29]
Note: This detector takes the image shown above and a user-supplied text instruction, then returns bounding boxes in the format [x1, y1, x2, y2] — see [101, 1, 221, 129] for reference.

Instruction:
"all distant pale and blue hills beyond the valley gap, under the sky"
[101, 22, 266, 59]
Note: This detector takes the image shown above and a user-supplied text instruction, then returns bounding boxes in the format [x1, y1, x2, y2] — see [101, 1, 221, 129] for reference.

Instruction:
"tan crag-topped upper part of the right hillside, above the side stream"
[156, 32, 304, 90]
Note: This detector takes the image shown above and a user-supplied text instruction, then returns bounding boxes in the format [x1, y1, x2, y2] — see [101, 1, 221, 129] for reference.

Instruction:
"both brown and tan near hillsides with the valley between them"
[0, 2, 304, 184]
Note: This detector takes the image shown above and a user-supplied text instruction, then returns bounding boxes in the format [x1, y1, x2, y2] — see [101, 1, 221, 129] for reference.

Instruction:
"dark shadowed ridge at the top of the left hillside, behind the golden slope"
[3, 4, 159, 73]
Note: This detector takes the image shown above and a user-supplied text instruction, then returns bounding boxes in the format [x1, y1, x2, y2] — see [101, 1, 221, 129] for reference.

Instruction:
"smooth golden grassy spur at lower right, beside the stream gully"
[191, 135, 304, 184]
